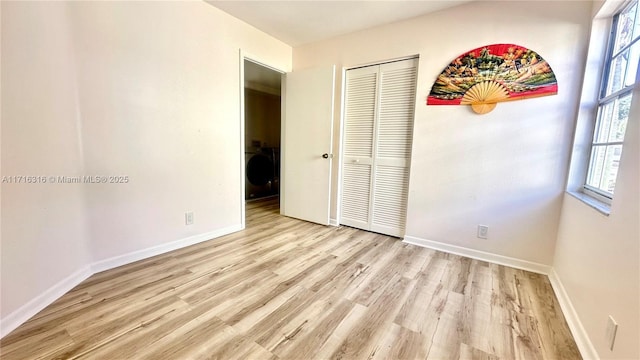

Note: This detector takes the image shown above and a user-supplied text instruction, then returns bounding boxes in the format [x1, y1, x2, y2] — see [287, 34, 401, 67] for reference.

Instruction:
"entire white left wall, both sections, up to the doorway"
[1, 2, 292, 329]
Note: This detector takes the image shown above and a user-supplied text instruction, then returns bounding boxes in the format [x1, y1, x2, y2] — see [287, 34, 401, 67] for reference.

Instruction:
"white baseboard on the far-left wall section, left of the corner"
[0, 265, 93, 338]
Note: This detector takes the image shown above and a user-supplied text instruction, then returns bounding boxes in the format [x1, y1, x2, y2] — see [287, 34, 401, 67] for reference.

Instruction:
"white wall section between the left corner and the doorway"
[71, 2, 291, 260]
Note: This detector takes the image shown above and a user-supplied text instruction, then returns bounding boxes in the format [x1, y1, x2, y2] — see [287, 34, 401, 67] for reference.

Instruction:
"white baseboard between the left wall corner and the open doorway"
[91, 224, 242, 274]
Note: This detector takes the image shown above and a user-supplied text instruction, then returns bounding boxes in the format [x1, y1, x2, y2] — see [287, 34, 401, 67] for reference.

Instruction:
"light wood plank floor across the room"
[0, 197, 580, 360]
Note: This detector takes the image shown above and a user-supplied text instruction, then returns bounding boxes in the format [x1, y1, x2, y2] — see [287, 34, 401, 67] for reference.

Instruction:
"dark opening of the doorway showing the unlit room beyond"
[243, 58, 282, 214]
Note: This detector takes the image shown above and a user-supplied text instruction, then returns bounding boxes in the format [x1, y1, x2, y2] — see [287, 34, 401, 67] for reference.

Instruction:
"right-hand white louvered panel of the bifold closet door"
[370, 59, 418, 236]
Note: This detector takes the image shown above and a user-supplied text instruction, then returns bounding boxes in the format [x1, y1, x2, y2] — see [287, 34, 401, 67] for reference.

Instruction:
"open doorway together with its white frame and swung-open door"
[240, 58, 335, 228]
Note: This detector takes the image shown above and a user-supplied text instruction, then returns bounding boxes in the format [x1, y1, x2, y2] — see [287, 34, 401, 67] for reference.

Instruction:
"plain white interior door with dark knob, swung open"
[280, 66, 335, 225]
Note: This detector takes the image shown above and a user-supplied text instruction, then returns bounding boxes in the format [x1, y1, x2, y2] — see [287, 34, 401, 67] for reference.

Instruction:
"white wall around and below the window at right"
[553, 2, 640, 359]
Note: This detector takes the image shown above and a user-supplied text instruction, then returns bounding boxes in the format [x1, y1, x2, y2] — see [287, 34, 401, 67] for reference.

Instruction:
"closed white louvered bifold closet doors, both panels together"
[340, 58, 418, 237]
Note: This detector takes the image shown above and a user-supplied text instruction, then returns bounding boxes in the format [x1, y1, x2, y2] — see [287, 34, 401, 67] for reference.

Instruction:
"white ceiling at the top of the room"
[206, 0, 474, 46]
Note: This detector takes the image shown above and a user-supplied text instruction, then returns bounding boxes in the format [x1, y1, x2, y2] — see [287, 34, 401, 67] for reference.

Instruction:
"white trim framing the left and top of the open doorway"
[239, 49, 286, 230]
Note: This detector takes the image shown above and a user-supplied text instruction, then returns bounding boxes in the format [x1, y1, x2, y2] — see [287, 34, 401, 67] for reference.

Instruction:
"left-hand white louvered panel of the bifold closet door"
[340, 66, 378, 230]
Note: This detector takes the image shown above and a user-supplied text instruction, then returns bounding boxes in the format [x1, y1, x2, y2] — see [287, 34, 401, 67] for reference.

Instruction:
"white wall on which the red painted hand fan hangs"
[293, 1, 591, 265]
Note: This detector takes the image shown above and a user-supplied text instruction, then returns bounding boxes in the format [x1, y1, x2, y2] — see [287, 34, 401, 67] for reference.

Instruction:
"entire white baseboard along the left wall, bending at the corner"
[0, 224, 242, 339]
